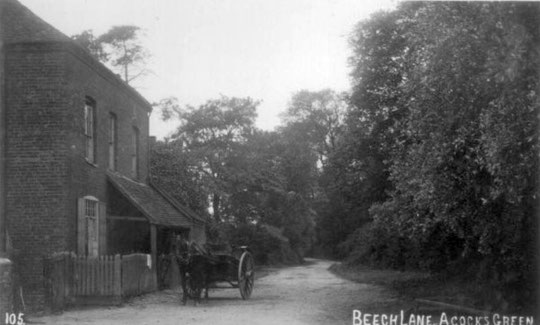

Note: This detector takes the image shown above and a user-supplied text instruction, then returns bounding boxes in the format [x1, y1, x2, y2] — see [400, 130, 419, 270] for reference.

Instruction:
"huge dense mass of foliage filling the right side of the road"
[336, 2, 540, 308]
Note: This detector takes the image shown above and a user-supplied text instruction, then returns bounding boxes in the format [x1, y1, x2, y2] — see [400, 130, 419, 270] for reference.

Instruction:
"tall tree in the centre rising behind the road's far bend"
[279, 89, 347, 256]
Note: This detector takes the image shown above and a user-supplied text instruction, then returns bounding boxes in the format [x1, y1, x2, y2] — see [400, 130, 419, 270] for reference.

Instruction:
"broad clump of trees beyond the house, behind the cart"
[153, 96, 316, 258]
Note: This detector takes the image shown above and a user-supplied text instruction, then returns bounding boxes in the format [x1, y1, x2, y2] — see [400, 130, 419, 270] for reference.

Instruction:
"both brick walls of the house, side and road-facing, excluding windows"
[5, 43, 152, 309]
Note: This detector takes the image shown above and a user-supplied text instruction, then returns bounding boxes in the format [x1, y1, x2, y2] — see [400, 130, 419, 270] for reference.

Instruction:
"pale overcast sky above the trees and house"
[19, 0, 396, 139]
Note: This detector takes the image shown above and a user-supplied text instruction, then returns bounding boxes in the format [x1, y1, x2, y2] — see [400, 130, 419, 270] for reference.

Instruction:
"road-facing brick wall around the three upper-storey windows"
[66, 44, 148, 253]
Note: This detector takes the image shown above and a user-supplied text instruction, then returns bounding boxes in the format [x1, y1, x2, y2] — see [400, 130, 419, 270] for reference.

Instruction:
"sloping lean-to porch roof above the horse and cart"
[107, 172, 198, 228]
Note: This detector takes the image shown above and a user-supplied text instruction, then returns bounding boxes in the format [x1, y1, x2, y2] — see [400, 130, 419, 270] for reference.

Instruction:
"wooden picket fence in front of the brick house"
[44, 253, 157, 311]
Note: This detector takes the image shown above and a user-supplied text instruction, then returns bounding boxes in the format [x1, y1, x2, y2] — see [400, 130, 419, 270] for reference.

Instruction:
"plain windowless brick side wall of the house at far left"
[5, 45, 67, 305]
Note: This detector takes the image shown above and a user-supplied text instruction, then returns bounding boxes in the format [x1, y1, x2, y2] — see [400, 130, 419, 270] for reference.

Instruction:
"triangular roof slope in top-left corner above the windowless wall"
[0, 0, 71, 43]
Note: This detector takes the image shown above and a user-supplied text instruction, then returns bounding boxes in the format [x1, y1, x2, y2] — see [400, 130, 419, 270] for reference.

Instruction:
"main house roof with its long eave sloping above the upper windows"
[0, 0, 152, 112]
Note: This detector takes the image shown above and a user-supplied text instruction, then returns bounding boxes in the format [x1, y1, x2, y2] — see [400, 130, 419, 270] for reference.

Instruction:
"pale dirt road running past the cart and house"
[29, 260, 408, 325]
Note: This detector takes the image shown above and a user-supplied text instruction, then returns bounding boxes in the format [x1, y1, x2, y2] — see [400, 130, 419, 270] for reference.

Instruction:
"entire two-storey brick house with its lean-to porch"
[0, 0, 205, 306]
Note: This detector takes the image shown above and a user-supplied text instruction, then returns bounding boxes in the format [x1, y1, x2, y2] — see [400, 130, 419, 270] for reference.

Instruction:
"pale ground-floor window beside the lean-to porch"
[77, 196, 106, 256]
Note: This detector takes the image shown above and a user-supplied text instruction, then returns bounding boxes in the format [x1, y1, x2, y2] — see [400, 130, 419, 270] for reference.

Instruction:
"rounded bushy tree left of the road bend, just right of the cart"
[247, 131, 317, 259]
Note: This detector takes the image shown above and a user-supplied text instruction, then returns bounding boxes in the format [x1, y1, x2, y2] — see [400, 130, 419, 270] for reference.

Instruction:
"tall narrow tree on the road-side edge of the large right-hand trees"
[317, 12, 407, 257]
